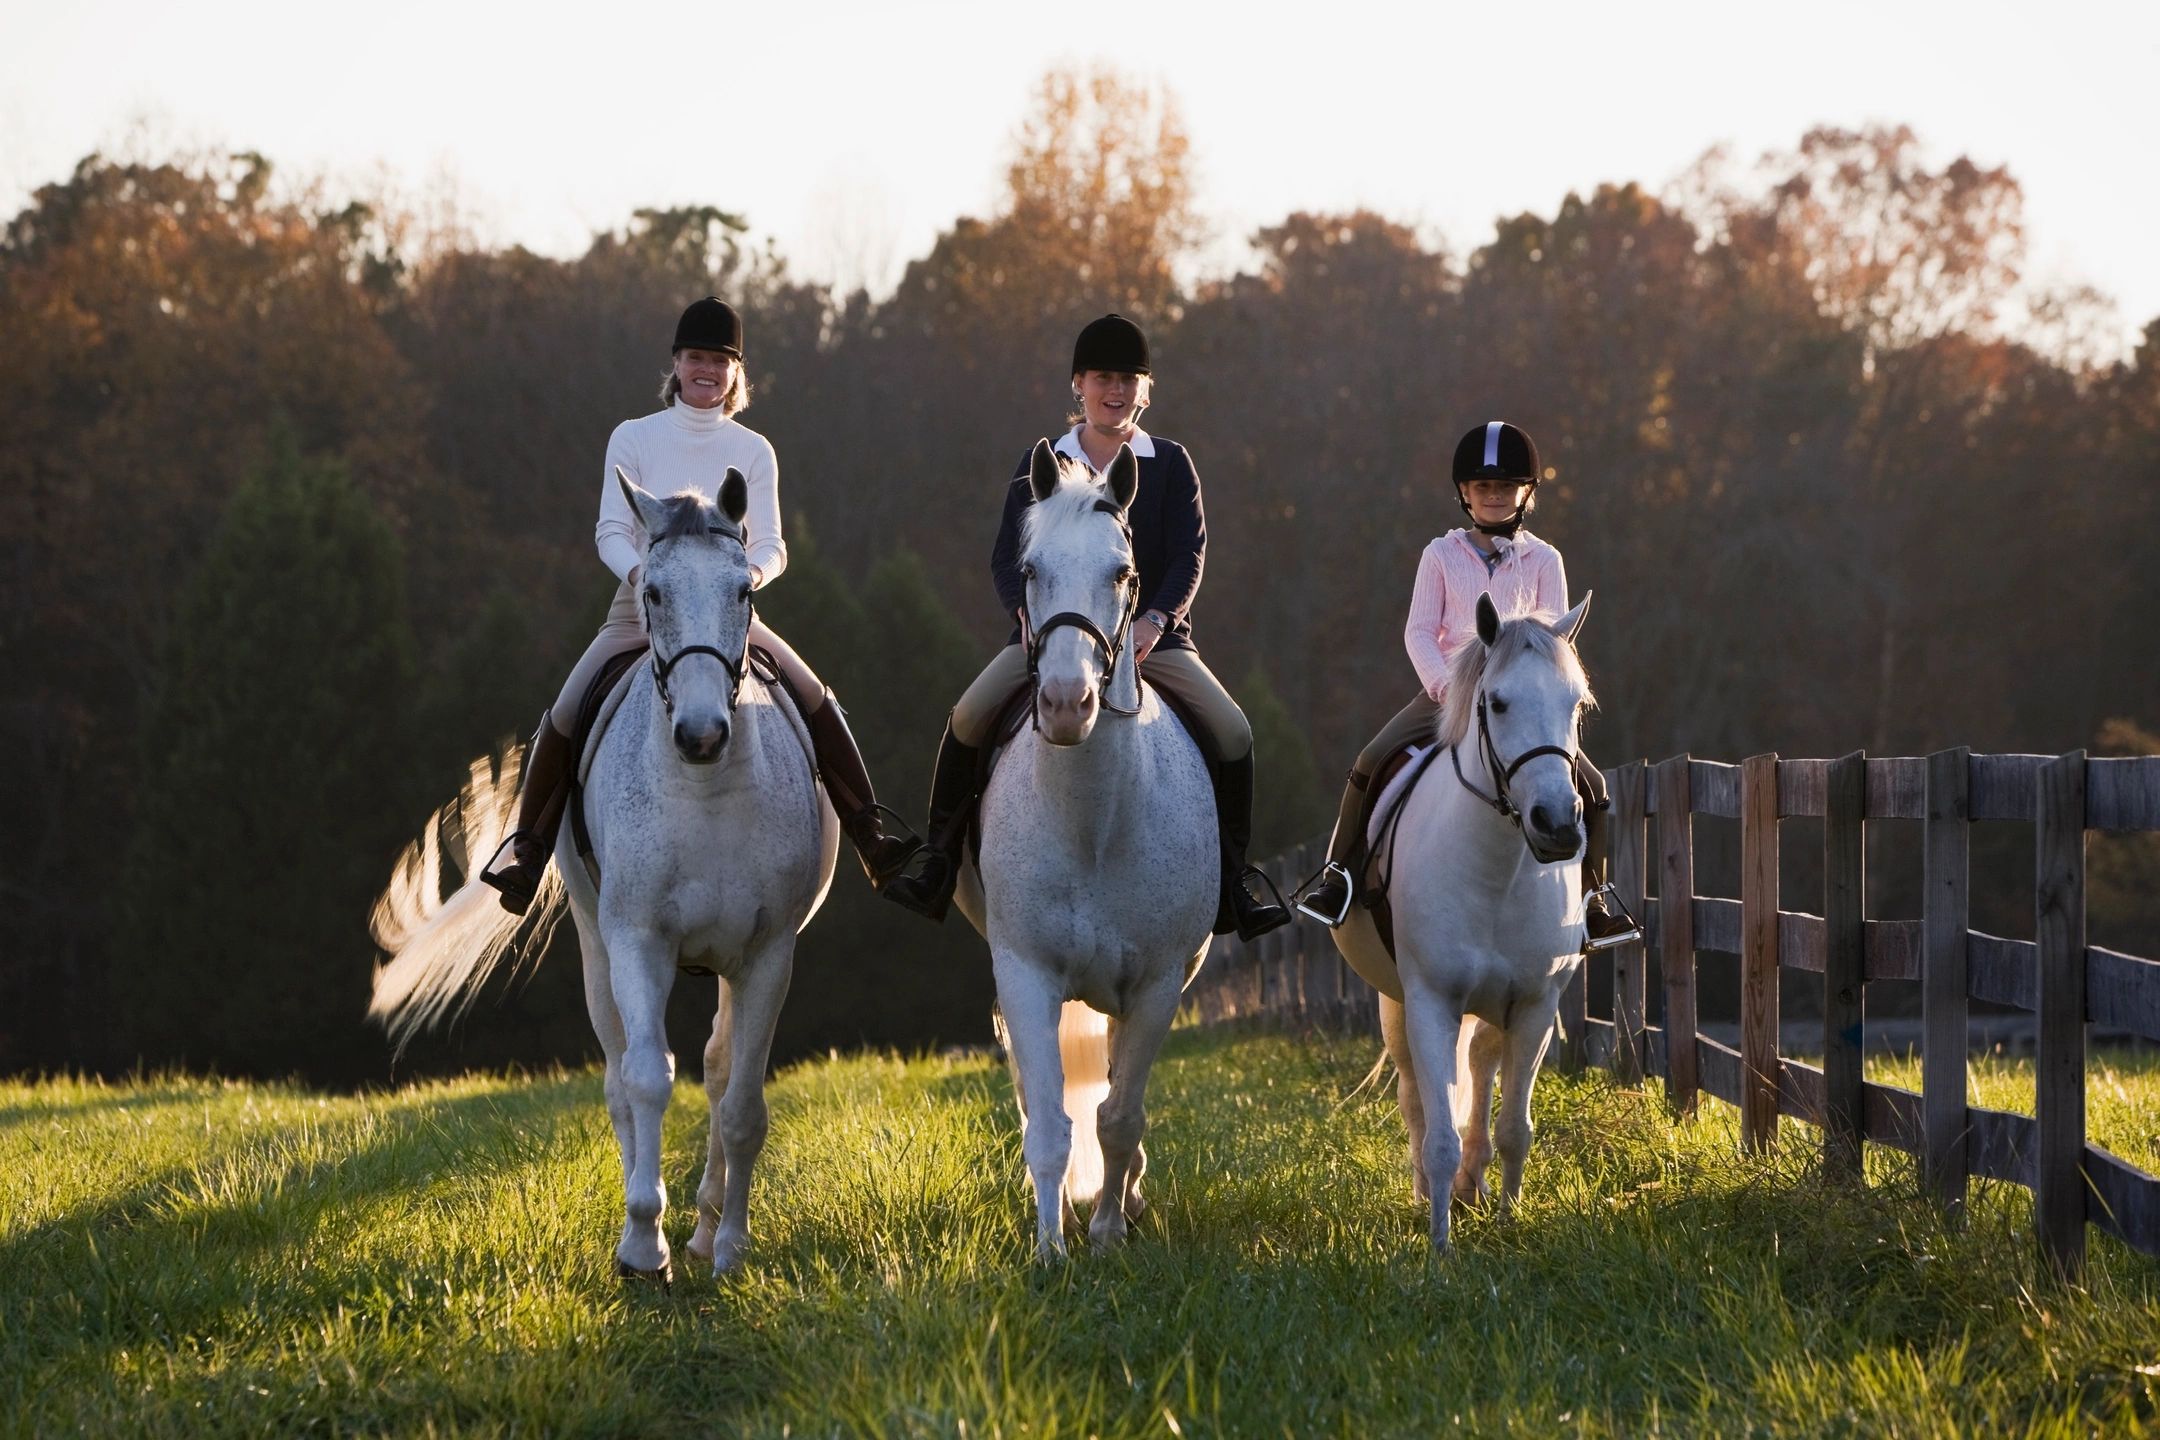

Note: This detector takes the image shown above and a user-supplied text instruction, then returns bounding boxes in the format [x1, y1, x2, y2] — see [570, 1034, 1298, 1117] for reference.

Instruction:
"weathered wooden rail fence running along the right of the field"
[1188, 749, 2160, 1274]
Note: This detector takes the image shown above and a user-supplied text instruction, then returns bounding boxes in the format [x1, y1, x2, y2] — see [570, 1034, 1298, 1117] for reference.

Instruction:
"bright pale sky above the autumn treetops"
[0, 0, 2160, 354]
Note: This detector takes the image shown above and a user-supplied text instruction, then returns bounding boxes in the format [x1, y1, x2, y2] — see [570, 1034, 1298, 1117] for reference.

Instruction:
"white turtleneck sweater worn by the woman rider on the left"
[592, 399, 788, 587]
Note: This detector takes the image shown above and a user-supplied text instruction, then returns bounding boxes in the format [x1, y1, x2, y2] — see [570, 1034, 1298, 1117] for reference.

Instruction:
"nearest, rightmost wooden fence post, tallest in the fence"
[2033, 749, 2084, 1276]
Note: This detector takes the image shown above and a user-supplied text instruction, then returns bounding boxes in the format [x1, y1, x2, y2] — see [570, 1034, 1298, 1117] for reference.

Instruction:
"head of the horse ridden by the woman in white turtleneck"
[616, 466, 752, 764]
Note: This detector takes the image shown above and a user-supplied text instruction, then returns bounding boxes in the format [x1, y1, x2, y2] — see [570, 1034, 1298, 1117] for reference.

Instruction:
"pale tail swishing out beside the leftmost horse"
[367, 745, 564, 1054]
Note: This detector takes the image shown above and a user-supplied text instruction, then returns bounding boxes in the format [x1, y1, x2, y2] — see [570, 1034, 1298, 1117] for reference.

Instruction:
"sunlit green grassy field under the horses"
[0, 1032, 2160, 1438]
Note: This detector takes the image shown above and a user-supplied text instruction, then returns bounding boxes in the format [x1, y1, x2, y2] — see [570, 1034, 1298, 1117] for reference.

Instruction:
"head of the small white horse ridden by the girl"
[1441, 594, 1592, 864]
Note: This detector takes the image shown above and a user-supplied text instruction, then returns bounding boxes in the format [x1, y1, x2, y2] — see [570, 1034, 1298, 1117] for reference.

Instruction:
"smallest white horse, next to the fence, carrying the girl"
[1335, 594, 1590, 1252]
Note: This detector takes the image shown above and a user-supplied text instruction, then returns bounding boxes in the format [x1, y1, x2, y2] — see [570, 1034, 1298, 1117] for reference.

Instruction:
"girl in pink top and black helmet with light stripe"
[1298, 421, 1637, 950]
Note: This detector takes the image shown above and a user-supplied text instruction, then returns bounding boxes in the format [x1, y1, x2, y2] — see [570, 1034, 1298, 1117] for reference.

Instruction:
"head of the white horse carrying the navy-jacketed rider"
[1020, 440, 1140, 745]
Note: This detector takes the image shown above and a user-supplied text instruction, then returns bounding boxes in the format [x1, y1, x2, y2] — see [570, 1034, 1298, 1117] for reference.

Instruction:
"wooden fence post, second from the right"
[1920, 747, 1972, 1213]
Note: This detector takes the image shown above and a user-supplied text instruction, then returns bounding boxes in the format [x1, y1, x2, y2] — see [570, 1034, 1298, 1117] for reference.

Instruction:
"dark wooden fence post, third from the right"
[1823, 751, 1868, 1179]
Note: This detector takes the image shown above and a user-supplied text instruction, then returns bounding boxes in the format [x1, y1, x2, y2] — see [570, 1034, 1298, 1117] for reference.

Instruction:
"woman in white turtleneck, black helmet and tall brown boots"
[480, 296, 920, 913]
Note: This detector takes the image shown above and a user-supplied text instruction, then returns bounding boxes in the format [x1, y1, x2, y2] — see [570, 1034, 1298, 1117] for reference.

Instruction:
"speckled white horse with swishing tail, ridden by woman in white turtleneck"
[369, 468, 840, 1282]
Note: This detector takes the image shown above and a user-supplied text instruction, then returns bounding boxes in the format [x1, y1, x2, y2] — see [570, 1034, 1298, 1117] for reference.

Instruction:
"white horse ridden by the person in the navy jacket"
[959, 443, 1223, 1261]
